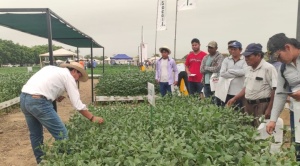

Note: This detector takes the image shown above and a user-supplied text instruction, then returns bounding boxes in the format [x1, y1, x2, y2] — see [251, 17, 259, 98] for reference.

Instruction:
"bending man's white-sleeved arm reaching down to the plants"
[65, 76, 104, 123]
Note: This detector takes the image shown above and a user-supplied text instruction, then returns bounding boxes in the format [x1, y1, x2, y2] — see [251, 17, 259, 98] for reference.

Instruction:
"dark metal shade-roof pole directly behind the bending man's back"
[46, 9, 57, 112]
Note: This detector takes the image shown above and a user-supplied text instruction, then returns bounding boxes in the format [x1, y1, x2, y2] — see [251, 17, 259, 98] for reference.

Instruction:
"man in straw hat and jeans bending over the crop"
[20, 62, 104, 163]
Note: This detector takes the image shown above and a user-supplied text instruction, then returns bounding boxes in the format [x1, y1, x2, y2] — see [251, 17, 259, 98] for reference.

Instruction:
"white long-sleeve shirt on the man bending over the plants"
[22, 66, 87, 111]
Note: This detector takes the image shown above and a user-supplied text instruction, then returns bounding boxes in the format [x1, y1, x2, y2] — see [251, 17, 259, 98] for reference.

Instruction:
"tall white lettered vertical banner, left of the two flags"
[156, 0, 167, 31]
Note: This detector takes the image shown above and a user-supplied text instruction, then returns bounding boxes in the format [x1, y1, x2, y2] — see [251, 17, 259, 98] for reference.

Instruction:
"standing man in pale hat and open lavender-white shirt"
[155, 46, 178, 96]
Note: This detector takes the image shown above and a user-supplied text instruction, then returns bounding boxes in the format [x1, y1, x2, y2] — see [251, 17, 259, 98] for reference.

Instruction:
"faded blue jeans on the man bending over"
[20, 93, 68, 163]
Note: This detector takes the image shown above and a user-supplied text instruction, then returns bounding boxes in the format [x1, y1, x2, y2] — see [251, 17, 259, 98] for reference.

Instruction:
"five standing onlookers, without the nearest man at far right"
[155, 38, 277, 127]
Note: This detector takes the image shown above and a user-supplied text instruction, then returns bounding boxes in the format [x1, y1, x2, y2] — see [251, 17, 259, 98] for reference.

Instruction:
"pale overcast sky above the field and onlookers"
[0, 0, 298, 58]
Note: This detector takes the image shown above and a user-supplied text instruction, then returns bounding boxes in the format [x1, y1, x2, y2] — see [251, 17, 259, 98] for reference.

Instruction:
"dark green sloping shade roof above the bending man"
[0, 8, 103, 48]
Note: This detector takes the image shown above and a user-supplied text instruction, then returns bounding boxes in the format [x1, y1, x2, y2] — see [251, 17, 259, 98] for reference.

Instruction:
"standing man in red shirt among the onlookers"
[185, 38, 206, 95]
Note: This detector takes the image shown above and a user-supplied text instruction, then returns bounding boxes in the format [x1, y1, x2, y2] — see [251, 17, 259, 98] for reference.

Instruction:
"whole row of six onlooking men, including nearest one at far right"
[155, 33, 300, 158]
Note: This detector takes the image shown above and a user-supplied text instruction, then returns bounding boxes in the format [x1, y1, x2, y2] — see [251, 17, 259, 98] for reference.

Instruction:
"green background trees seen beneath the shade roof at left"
[0, 39, 62, 66]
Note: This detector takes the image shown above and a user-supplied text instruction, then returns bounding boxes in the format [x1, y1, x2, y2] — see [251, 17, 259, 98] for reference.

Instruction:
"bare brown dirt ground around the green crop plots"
[0, 80, 289, 166]
